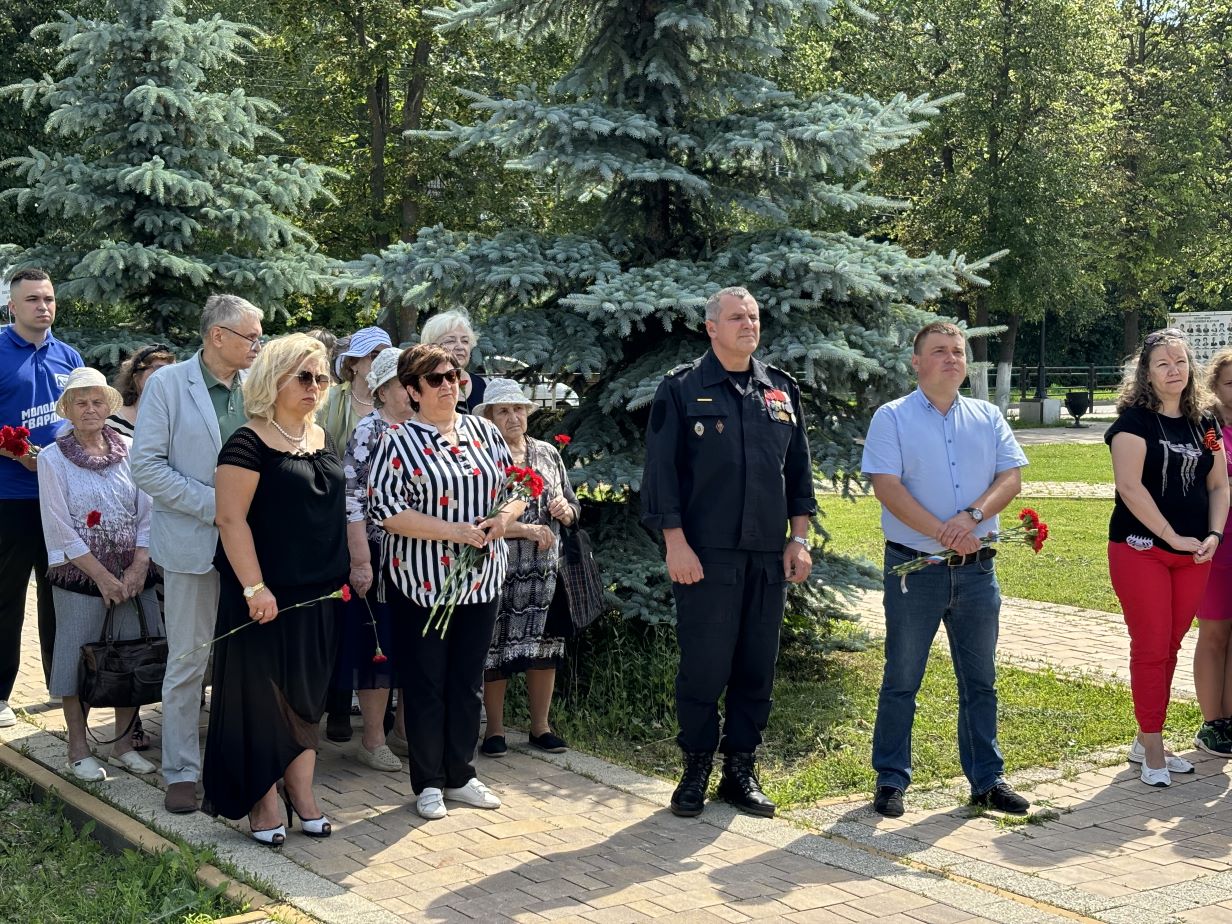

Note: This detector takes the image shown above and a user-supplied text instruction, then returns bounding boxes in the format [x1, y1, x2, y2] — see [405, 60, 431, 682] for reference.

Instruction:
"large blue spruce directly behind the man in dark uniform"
[344, 0, 1000, 626]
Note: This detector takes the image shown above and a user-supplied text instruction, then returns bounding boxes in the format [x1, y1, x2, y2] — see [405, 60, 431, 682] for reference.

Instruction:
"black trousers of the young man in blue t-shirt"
[0, 500, 55, 700]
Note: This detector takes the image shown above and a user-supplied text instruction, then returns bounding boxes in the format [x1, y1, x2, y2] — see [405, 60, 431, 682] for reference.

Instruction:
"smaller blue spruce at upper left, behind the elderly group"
[0, 0, 331, 340]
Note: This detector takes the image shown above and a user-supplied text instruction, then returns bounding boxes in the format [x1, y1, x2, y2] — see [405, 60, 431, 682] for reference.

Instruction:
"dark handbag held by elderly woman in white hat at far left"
[78, 596, 166, 708]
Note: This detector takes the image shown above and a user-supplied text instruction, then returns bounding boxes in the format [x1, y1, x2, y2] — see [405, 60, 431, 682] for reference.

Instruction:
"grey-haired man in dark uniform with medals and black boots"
[642, 287, 817, 817]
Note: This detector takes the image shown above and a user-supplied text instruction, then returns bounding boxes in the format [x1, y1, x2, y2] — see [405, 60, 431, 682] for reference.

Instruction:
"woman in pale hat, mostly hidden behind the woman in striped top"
[334, 350, 411, 772]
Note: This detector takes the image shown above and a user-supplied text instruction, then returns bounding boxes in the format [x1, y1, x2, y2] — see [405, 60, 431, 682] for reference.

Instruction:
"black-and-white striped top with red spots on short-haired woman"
[367, 414, 514, 606]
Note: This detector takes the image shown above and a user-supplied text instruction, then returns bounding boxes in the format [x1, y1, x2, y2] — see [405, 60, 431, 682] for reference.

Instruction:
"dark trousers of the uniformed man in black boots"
[671, 548, 787, 754]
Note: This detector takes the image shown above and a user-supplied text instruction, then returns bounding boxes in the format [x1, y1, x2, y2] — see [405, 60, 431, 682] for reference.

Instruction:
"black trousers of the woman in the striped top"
[387, 580, 498, 796]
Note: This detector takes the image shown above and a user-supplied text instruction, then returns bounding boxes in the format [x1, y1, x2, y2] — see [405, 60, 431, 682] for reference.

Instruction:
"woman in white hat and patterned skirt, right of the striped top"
[474, 378, 582, 758]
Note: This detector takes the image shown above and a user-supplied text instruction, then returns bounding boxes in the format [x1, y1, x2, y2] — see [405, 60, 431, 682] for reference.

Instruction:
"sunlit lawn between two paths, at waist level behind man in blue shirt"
[822, 498, 1121, 612]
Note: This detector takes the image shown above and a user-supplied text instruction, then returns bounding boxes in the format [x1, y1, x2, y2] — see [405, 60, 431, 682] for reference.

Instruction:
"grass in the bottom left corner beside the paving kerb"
[0, 770, 239, 924]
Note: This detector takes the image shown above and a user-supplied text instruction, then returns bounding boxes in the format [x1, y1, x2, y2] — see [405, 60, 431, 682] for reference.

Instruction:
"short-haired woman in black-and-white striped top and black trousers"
[368, 344, 524, 818]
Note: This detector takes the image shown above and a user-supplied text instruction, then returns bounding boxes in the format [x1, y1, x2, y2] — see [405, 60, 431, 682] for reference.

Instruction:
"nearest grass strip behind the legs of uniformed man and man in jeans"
[557, 644, 1201, 806]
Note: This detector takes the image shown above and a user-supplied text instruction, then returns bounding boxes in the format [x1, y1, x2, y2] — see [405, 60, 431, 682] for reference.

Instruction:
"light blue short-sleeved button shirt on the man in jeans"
[860, 388, 1026, 552]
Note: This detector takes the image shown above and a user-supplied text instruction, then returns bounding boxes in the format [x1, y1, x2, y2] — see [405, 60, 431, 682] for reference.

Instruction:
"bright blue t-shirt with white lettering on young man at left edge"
[0, 324, 85, 500]
